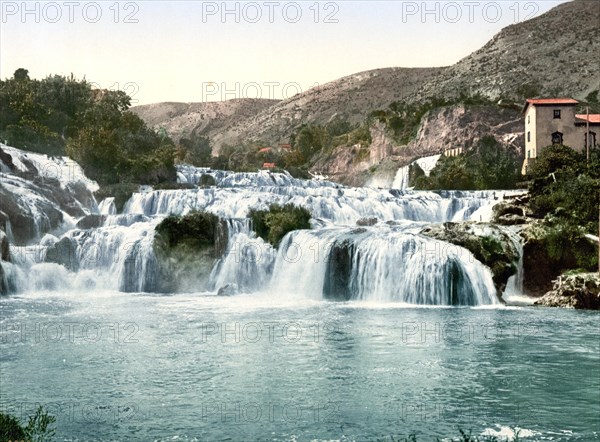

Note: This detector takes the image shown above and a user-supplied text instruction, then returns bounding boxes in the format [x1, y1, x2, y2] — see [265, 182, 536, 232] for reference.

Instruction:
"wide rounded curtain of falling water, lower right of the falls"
[270, 226, 499, 306]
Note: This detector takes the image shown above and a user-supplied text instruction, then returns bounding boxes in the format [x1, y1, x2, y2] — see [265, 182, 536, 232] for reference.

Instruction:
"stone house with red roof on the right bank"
[521, 98, 600, 175]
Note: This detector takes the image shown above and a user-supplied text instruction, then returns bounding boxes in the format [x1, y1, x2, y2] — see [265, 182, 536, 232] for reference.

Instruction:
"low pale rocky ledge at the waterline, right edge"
[534, 273, 600, 310]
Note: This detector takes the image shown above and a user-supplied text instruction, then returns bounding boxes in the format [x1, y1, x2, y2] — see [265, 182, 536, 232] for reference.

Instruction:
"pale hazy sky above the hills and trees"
[0, 0, 565, 104]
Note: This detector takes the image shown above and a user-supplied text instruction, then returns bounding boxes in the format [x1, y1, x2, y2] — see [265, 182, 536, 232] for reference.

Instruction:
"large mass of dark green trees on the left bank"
[0, 68, 175, 184]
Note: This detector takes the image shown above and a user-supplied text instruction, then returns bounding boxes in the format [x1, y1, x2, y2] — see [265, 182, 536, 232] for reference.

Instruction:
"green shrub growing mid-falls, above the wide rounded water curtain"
[248, 204, 310, 247]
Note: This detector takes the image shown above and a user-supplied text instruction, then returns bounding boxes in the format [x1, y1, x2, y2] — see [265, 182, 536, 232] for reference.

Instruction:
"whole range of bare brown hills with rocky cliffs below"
[133, 0, 600, 180]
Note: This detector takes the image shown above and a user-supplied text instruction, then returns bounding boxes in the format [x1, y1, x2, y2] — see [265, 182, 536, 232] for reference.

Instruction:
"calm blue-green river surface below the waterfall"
[0, 291, 600, 441]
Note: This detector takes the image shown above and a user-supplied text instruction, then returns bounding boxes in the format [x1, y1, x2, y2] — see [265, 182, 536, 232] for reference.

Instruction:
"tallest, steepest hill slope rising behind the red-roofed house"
[416, 0, 600, 100]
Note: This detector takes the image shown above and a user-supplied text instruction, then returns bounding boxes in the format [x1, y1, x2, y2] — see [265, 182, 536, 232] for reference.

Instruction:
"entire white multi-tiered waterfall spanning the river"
[2, 150, 520, 306]
